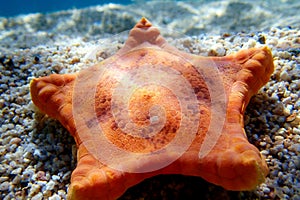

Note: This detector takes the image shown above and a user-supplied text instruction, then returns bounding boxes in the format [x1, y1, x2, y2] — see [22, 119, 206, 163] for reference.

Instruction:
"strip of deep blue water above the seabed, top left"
[0, 0, 132, 17]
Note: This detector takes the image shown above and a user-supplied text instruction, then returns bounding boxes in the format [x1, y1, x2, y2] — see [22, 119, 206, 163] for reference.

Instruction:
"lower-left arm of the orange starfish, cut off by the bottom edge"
[67, 145, 157, 200]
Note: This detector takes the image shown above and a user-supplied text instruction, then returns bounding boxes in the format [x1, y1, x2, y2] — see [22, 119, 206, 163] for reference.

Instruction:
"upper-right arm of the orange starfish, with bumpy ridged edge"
[191, 47, 274, 124]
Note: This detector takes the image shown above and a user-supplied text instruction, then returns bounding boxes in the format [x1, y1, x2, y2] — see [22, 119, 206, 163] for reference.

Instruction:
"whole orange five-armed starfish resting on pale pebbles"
[30, 18, 274, 199]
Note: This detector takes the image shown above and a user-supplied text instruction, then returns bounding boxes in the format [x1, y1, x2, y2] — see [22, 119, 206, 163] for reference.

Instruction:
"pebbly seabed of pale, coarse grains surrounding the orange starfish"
[0, 0, 300, 200]
